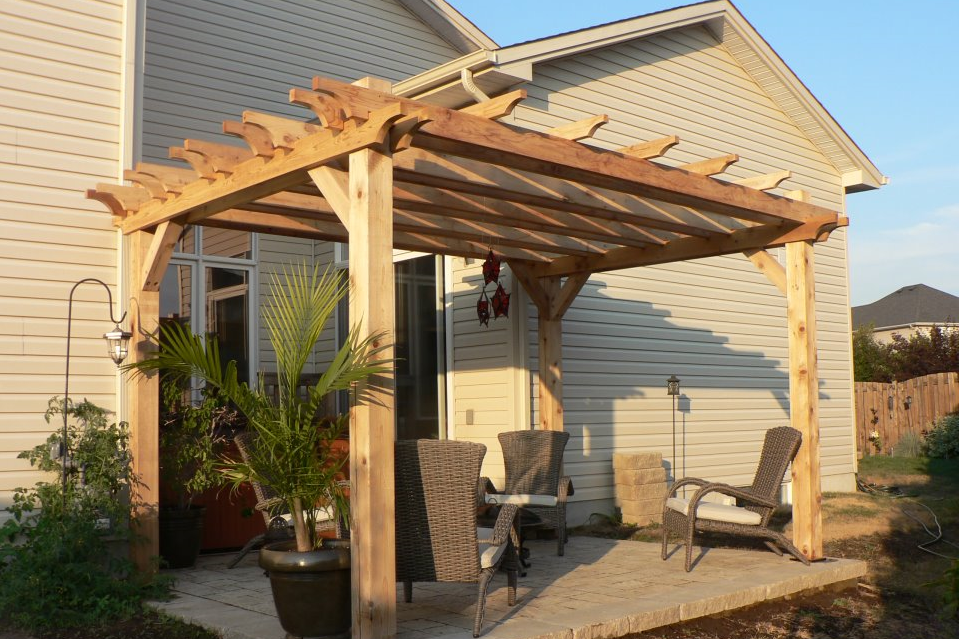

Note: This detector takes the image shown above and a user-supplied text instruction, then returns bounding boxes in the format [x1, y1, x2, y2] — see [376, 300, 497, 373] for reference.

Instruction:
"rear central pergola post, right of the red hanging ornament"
[539, 276, 563, 430]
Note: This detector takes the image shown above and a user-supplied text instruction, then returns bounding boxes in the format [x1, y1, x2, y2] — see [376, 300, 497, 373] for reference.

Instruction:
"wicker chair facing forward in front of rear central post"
[482, 430, 573, 556]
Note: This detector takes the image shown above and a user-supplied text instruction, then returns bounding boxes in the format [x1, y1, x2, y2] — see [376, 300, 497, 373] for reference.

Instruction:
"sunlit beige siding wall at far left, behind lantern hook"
[0, 0, 123, 508]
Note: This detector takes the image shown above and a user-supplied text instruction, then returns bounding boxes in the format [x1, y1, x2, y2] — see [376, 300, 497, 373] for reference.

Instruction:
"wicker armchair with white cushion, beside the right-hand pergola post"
[662, 426, 809, 572]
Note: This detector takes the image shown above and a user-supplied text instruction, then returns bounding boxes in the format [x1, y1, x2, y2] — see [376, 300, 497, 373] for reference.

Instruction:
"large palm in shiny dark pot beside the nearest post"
[132, 266, 390, 636]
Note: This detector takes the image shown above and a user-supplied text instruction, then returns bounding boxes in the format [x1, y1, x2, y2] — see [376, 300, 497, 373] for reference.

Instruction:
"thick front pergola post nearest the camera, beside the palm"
[349, 79, 396, 639]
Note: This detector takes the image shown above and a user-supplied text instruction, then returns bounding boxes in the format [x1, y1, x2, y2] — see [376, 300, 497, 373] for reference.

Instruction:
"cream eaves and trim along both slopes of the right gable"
[393, 0, 888, 192]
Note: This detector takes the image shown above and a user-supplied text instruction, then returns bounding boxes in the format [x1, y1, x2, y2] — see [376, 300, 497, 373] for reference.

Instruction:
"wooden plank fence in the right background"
[856, 373, 959, 455]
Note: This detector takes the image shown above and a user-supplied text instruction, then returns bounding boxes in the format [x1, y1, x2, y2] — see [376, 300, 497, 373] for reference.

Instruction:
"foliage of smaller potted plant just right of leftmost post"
[160, 377, 237, 510]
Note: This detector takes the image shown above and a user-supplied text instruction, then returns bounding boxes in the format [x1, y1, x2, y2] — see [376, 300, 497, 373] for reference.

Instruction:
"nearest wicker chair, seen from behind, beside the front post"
[395, 439, 517, 637]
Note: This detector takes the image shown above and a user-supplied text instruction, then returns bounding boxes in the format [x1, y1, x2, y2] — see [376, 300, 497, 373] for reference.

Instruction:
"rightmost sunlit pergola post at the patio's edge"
[786, 242, 823, 559]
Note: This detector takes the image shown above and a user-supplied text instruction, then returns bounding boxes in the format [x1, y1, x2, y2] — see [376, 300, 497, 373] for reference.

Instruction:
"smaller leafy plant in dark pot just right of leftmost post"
[159, 376, 237, 568]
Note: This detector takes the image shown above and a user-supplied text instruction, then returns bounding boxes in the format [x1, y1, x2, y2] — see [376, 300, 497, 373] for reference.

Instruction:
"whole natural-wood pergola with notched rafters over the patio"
[87, 77, 846, 639]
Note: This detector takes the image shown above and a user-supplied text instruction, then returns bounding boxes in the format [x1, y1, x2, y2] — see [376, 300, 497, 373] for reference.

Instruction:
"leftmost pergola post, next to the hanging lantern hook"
[127, 231, 160, 571]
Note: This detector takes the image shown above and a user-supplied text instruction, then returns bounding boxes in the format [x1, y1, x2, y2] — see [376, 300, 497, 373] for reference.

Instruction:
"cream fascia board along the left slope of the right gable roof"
[494, 0, 732, 70]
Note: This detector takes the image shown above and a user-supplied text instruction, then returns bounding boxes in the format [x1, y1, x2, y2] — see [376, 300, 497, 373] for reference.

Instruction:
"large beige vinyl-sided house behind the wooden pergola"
[0, 0, 885, 552]
